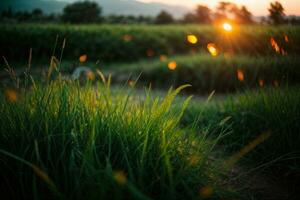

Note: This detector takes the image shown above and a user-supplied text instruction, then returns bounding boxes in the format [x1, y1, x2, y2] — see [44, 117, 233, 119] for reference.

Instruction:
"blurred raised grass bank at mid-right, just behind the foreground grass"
[106, 54, 300, 93]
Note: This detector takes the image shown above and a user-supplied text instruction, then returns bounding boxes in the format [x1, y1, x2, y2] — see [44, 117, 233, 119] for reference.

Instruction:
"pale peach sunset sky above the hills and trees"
[138, 0, 300, 16]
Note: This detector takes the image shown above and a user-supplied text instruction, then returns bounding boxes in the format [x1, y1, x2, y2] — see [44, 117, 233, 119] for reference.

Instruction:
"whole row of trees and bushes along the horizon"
[0, 1, 300, 24]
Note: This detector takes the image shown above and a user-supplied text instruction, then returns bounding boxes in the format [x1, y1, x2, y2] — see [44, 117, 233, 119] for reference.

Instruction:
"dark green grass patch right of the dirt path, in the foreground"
[182, 87, 300, 173]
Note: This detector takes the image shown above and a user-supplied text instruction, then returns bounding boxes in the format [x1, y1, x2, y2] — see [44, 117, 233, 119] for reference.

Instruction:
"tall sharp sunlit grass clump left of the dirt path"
[0, 81, 234, 199]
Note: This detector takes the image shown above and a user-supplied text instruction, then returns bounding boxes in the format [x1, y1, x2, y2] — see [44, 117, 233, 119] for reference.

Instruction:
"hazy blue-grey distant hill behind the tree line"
[0, 0, 189, 17]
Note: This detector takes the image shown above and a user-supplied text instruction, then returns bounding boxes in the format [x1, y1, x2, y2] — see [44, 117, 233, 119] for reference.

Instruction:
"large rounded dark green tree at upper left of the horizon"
[62, 1, 102, 23]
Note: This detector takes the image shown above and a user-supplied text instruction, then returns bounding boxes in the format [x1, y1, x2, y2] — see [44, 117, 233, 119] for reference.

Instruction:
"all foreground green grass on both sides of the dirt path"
[0, 71, 300, 199]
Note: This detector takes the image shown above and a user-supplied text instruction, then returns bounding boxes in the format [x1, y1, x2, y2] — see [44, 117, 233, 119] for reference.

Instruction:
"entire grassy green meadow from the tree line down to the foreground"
[0, 24, 300, 200]
